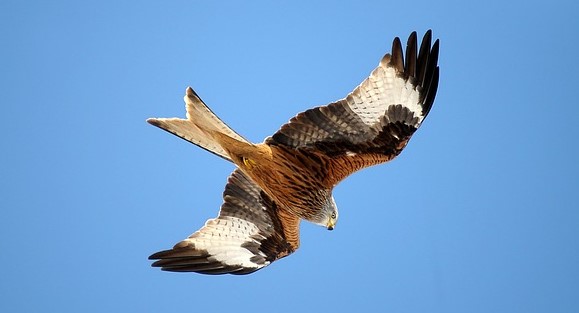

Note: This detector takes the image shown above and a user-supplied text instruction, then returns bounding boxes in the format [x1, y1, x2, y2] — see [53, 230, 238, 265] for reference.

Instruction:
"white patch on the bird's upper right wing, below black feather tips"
[346, 58, 424, 127]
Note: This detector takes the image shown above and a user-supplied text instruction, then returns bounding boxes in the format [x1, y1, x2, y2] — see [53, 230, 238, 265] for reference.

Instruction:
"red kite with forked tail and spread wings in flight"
[147, 30, 439, 274]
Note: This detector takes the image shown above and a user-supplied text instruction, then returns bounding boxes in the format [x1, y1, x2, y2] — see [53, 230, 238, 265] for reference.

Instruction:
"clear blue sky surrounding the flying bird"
[0, 0, 579, 313]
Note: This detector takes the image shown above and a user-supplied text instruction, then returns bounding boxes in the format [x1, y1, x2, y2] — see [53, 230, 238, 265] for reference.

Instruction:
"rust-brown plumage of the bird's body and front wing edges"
[213, 127, 402, 249]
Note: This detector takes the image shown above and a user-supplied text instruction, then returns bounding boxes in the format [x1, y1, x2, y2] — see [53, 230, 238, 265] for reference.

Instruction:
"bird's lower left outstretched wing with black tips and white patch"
[149, 169, 299, 274]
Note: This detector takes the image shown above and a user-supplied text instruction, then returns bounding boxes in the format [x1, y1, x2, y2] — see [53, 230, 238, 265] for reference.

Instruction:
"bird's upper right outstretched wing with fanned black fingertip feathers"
[265, 30, 439, 185]
